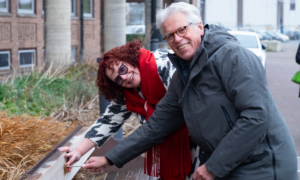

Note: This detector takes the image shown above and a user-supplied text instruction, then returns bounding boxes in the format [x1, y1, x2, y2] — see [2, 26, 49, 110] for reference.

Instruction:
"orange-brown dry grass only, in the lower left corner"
[0, 112, 79, 180]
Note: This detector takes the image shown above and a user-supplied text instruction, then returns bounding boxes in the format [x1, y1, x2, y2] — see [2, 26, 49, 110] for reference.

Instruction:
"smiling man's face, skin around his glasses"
[163, 12, 204, 61]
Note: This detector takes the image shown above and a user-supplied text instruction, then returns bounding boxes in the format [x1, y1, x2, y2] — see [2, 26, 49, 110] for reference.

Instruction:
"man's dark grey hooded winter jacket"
[105, 25, 298, 180]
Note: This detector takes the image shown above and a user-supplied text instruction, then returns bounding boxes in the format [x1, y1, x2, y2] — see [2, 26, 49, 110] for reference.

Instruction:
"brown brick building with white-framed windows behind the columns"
[0, 0, 100, 77]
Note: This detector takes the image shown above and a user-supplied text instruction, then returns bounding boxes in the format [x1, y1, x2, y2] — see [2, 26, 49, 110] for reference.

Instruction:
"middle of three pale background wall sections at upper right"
[243, 0, 277, 31]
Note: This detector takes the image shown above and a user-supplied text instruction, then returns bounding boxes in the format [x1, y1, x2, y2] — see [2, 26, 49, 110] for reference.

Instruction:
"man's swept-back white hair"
[156, 2, 202, 36]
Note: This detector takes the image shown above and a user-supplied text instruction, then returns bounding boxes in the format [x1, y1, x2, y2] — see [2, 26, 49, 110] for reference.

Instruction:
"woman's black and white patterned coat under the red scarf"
[85, 49, 207, 180]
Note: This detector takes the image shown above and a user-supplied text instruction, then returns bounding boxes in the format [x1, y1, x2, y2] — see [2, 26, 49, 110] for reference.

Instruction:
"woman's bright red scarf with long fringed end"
[123, 49, 191, 179]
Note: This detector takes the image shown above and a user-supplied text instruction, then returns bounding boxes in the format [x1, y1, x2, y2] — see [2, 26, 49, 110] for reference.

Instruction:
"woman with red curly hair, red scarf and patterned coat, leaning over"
[60, 40, 203, 180]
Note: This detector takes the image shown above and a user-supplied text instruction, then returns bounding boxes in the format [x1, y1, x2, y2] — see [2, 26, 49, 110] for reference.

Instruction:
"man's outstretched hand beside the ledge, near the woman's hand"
[82, 156, 110, 172]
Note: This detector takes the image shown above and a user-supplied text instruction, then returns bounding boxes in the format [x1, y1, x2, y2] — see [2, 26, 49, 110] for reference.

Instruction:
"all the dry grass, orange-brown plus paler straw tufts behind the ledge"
[0, 92, 99, 180]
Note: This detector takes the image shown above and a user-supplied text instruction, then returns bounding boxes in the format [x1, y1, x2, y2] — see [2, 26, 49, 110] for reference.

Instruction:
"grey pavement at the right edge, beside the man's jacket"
[266, 40, 300, 177]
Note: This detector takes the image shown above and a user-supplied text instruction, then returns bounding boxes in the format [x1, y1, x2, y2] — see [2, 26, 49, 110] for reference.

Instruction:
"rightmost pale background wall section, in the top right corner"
[283, 0, 300, 32]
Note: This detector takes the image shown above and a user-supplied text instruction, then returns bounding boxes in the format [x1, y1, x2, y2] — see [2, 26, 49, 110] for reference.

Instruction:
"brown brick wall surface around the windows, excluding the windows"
[0, 0, 101, 76]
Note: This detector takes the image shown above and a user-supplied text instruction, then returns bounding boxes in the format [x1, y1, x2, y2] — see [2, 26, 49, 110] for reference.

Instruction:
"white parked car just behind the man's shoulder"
[228, 31, 267, 68]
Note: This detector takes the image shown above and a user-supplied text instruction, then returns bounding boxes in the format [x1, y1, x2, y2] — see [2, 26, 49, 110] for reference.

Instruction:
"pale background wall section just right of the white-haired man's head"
[205, 0, 237, 29]
